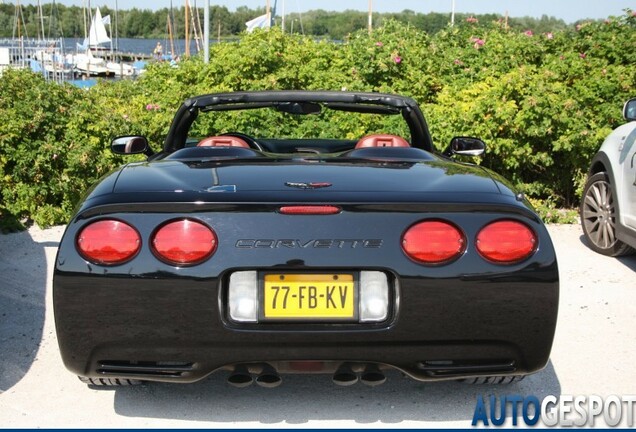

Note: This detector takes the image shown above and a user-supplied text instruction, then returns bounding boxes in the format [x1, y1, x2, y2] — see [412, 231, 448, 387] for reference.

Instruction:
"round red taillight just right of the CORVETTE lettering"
[402, 220, 466, 265]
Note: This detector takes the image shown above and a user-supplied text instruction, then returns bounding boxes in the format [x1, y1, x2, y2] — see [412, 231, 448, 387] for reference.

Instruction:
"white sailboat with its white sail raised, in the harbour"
[73, 8, 115, 76]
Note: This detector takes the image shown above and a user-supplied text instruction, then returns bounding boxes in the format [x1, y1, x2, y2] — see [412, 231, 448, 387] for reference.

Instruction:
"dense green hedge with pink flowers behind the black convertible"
[0, 11, 636, 228]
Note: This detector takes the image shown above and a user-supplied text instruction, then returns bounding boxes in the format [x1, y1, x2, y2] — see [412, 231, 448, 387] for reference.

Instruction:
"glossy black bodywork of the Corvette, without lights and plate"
[54, 92, 559, 382]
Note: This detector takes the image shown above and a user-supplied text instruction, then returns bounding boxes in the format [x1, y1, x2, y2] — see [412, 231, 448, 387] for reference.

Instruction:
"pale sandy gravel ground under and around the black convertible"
[0, 225, 636, 428]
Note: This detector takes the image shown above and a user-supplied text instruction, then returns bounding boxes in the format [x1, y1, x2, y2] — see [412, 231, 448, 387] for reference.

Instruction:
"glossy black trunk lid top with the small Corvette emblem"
[114, 159, 500, 197]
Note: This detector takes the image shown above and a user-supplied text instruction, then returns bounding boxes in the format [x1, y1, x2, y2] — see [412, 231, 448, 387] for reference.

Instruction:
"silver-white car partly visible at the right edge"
[580, 98, 636, 256]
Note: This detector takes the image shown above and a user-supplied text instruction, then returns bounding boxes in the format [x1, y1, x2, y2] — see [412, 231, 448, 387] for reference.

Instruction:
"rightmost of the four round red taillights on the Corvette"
[475, 220, 537, 264]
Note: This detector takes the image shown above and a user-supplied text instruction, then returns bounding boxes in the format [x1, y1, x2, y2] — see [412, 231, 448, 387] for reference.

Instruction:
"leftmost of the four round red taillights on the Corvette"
[76, 219, 141, 265]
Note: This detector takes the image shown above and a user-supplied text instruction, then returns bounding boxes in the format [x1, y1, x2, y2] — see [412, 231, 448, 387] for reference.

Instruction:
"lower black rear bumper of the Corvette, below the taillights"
[54, 261, 558, 382]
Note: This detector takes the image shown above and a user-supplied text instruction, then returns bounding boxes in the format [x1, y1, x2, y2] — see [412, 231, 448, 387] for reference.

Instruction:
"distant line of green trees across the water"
[0, 2, 578, 40]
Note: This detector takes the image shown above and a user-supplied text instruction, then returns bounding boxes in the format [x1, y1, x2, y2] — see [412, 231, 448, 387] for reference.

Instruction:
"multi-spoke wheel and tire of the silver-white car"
[579, 172, 634, 257]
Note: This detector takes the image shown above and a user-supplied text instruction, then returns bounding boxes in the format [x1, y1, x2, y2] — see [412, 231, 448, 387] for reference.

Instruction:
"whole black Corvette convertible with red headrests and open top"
[53, 91, 559, 387]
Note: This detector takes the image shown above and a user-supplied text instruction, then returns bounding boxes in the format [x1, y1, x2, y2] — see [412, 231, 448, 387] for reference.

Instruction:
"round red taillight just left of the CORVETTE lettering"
[152, 219, 217, 266]
